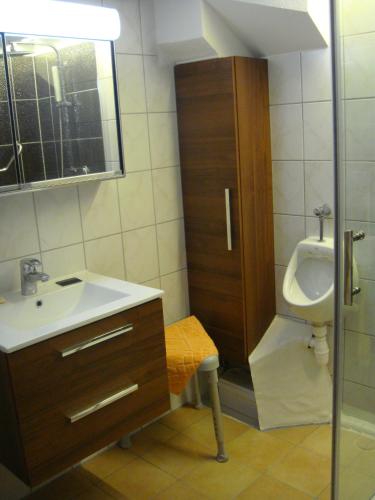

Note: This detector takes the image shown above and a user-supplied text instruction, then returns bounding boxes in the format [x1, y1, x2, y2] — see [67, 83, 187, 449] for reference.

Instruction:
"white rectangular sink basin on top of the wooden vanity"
[0, 271, 163, 353]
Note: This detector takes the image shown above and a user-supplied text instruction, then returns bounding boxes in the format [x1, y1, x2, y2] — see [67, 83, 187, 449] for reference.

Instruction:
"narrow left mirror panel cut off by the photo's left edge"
[0, 35, 18, 191]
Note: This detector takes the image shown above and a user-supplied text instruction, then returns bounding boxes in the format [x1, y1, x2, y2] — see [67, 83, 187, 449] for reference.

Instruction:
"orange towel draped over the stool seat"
[165, 316, 218, 394]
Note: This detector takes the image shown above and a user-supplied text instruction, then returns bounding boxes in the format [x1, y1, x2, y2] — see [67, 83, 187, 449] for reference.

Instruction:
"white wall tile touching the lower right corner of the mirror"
[118, 171, 155, 231]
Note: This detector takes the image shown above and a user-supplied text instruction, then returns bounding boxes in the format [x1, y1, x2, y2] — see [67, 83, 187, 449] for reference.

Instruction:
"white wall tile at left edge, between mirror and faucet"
[0, 193, 39, 261]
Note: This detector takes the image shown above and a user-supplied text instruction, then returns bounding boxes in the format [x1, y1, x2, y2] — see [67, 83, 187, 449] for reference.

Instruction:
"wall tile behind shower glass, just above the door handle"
[345, 162, 375, 222]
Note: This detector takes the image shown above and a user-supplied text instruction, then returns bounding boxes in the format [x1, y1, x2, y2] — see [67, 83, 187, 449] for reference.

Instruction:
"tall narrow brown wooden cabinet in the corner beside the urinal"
[175, 57, 275, 363]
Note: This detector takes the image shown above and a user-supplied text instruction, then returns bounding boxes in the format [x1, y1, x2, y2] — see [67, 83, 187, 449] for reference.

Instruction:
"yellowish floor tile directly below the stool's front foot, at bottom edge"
[182, 460, 259, 500]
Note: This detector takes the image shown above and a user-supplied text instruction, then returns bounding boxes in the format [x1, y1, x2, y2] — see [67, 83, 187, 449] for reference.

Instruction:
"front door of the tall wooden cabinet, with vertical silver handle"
[175, 58, 244, 361]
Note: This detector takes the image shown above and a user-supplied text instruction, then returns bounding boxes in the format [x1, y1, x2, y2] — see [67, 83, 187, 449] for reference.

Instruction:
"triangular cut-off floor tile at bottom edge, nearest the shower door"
[237, 475, 312, 500]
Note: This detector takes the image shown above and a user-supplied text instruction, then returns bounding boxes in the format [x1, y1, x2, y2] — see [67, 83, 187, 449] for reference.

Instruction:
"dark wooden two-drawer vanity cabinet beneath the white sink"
[0, 299, 169, 486]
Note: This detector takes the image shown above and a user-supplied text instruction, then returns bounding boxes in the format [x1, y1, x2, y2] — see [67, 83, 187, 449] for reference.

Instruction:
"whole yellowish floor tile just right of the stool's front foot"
[228, 429, 294, 472]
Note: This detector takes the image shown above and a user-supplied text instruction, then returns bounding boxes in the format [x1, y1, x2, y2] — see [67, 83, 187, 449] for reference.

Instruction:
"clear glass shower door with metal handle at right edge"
[331, 0, 375, 500]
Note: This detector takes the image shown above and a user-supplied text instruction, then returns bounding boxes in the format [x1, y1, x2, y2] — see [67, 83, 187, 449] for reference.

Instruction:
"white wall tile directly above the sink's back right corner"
[85, 234, 125, 280]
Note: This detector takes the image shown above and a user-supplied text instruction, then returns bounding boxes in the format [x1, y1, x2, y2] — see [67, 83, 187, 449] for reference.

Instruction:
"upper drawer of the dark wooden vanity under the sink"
[8, 300, 165, 419]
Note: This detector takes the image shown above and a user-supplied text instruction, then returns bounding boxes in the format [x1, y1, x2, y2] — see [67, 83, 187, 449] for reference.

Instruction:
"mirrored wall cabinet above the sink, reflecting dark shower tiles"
[0, 33, 124, 191]
